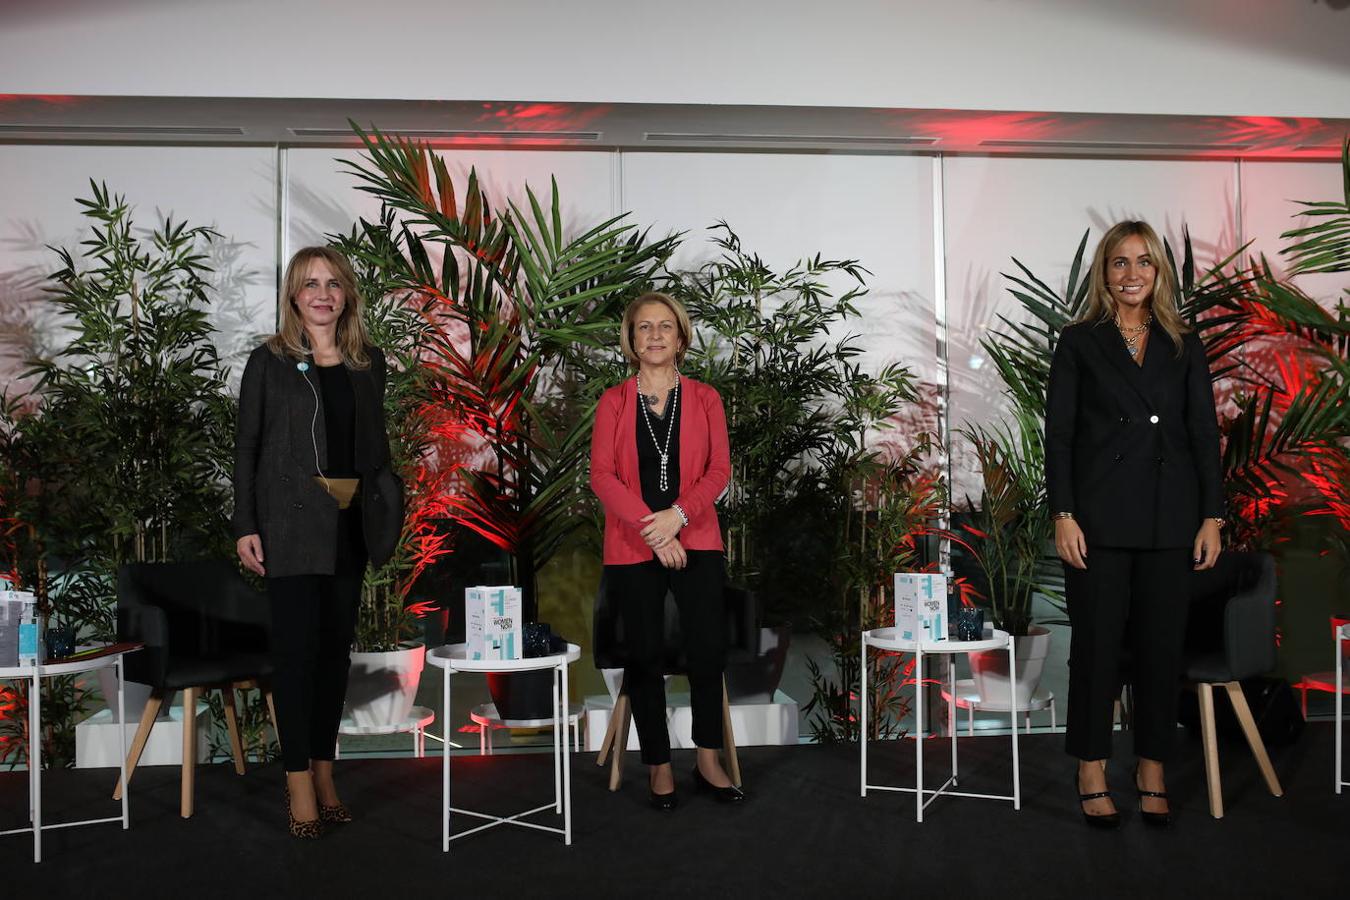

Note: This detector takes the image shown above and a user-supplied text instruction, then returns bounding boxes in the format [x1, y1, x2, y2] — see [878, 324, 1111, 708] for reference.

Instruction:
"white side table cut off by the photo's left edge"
[0, 644, 140, 862]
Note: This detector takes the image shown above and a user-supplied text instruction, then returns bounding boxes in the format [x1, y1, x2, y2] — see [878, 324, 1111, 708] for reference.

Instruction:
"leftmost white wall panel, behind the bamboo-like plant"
[0, 146, 277, 382]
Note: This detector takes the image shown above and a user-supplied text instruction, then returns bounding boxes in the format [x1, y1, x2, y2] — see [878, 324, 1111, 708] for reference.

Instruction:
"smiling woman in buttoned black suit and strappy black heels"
[1045, 221, 1223, 827]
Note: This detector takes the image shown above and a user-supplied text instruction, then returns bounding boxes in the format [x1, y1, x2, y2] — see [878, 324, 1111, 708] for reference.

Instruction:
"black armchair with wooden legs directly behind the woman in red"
[591, 573, 759, 791]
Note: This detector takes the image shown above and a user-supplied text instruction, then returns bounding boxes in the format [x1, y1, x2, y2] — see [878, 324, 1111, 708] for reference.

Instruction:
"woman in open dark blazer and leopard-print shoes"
[232, 247, 402, 838]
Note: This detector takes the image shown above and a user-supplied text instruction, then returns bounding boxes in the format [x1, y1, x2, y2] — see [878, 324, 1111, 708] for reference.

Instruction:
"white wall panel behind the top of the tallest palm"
[285, 148, 614, 264]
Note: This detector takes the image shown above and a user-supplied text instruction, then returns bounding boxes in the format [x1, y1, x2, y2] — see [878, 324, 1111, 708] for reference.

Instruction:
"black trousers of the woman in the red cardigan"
[605, 551, 726, 765]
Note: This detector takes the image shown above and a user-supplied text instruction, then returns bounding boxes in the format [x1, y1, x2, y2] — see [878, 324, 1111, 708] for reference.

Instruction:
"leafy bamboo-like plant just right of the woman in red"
[667, 223, 917, 623]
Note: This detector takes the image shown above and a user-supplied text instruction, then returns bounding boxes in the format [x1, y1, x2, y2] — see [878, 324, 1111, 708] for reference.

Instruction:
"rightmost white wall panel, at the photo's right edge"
[1242, 162, 1350, 309]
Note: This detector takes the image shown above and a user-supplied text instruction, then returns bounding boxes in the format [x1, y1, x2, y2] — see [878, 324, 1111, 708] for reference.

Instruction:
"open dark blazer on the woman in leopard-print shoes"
[232, 344, 404, 578]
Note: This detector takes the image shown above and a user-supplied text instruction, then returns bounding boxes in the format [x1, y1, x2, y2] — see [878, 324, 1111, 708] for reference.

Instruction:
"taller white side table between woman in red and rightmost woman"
[859, 627, 1022, 822]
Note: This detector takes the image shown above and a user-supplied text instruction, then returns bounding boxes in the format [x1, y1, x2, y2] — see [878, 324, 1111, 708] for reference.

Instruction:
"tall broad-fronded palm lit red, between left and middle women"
[337, 124, 675, 619]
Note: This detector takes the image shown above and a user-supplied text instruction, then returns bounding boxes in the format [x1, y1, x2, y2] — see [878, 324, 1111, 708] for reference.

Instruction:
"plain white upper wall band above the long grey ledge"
[0, 0, 1350, 117]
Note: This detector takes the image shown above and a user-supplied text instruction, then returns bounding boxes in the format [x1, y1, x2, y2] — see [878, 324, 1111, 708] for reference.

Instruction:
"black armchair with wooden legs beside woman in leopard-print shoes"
[113, 561, 277, 819]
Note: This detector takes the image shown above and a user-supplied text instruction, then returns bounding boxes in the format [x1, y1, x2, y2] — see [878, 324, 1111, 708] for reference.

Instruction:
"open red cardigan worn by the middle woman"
[591, 376, 732, 565]
